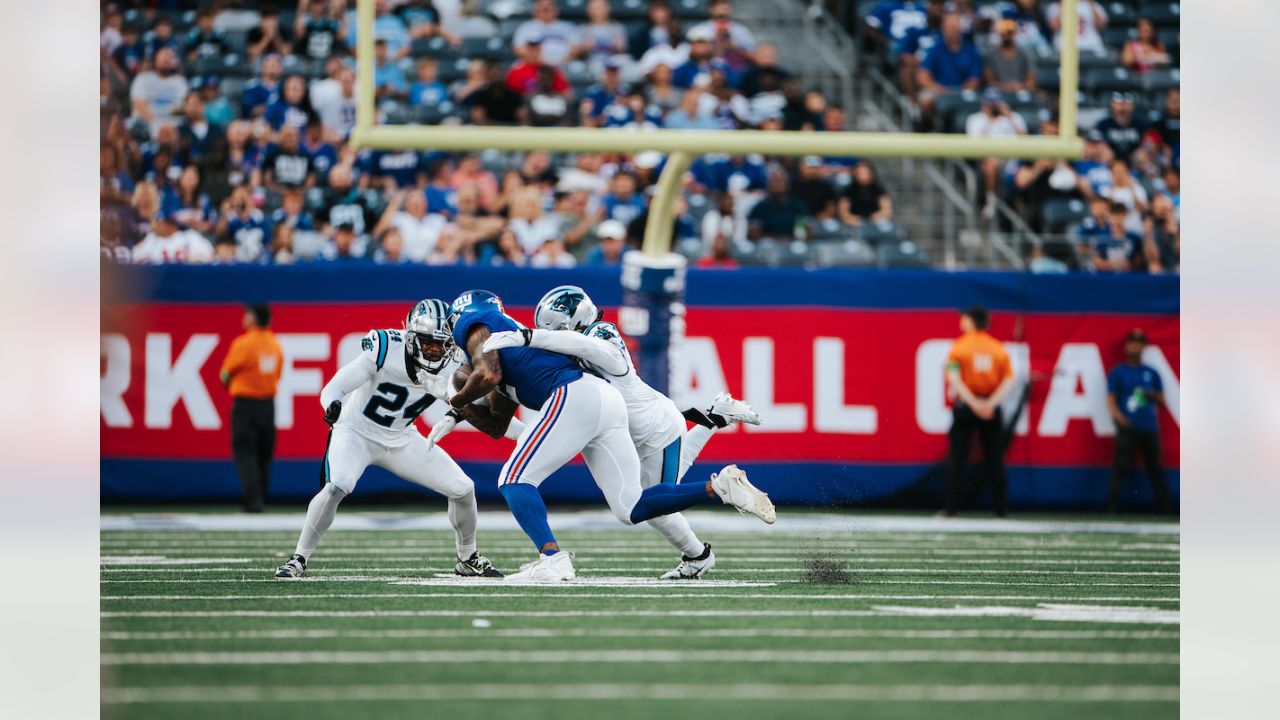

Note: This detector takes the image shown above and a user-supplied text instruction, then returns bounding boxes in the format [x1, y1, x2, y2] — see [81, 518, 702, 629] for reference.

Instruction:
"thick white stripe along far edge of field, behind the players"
[99, 509, 1180, 536]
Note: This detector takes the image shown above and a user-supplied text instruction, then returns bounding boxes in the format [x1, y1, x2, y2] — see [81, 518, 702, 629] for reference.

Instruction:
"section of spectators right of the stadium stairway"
[861, 0, 1181, 272]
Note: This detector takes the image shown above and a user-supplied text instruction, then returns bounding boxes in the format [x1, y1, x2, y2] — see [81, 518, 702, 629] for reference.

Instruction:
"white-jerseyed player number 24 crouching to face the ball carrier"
[275, 300, 504, 578]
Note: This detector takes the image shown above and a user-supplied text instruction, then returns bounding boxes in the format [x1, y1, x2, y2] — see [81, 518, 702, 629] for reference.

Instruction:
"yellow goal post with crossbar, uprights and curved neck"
[351, 0, 1083, 258]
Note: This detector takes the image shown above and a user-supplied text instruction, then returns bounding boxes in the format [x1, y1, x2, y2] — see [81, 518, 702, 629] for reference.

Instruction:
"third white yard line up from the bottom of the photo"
[101, 628, 1181, 641]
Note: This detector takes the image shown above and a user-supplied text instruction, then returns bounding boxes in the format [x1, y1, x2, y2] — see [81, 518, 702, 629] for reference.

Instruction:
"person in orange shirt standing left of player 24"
[219, 305, 284, 512]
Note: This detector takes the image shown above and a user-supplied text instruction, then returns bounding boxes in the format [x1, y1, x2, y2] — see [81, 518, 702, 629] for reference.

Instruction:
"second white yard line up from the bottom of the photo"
[101, 650, 1179, 666]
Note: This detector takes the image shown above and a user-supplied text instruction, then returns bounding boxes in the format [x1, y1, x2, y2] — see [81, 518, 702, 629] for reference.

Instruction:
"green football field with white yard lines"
[101, 509, 1179, 720]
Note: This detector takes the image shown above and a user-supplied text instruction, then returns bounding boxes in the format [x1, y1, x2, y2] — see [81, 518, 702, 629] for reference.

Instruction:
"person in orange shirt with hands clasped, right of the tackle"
[943, 305, 1014, 518]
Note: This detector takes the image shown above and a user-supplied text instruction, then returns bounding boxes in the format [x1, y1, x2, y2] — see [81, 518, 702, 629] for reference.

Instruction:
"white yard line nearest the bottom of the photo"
[101, 683, 1179, 705]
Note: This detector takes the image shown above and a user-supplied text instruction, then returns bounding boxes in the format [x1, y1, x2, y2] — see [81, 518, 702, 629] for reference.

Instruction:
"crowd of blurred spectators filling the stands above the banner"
[100, 0, 1178, 270]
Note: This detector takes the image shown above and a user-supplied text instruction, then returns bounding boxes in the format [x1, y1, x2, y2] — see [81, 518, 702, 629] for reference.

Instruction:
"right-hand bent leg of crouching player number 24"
[375, 430, 502, 578]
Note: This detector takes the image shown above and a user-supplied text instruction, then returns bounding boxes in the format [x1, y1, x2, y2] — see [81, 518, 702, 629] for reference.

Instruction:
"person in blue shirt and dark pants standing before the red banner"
[1107, 328, 1172, 512]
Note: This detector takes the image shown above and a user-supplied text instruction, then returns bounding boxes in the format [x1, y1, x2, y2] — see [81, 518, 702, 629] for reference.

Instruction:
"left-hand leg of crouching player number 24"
[275, 425, 376, 579]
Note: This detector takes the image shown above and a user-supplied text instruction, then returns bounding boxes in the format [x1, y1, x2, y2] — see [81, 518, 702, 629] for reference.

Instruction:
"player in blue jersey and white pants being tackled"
[431, 290, 776, 583]
